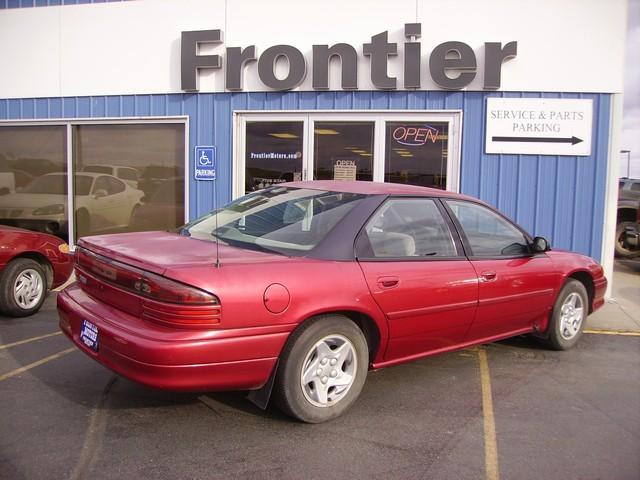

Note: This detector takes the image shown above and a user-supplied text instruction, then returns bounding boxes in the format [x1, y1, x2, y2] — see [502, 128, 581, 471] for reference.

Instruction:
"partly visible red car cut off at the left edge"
[0, 225, 73, 317]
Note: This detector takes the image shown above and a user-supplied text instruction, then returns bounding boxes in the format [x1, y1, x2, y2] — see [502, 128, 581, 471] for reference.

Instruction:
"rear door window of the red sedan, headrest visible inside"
[356, 198, 458, 259]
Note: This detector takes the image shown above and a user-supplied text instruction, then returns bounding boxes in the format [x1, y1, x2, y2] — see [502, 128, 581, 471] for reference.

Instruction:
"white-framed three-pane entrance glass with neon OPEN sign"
[233, 110, 462, 198]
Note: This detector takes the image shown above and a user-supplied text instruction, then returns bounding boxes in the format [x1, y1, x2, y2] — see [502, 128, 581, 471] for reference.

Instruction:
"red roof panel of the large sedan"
[284, 180, 478, 202]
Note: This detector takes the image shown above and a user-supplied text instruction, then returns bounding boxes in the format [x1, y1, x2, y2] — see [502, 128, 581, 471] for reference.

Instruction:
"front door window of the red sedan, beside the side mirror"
[447, 200, 530, 257]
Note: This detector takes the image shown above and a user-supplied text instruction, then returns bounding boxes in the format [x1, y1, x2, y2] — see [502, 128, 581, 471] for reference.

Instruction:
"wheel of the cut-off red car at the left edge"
[0, 258, 47, 317]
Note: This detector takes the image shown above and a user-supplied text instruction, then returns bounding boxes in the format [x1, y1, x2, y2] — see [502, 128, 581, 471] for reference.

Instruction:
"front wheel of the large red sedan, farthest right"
[541, 279, 589, 350]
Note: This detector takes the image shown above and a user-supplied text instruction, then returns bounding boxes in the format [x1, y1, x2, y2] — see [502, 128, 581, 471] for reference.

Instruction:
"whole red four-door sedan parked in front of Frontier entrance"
[58, 181, 607, 422]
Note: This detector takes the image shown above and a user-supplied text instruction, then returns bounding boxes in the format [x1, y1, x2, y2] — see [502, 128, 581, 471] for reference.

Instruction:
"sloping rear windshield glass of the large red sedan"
[182, 187, 364, 255]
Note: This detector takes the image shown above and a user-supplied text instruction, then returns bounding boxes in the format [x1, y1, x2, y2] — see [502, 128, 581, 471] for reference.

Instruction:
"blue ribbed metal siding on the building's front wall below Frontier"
[0, 91, 611, 258]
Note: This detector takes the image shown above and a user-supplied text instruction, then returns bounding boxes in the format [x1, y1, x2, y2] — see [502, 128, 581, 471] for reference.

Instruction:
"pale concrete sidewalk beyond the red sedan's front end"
[586, 260, 640, 332]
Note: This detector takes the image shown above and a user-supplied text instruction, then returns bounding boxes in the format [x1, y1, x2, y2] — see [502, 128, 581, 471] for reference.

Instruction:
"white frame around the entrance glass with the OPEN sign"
[232, 109, 463, 200]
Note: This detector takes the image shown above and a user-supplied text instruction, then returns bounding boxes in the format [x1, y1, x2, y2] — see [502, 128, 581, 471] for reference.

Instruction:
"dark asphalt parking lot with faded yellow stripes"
[0, 295, 640, 480]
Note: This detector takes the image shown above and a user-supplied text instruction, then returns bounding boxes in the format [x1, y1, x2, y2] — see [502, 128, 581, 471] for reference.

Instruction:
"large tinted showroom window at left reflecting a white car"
[0, 118, 188, 244]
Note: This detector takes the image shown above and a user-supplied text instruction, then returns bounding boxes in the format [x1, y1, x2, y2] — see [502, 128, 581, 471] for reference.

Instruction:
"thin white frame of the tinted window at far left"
[0, 115, 190, 251]
